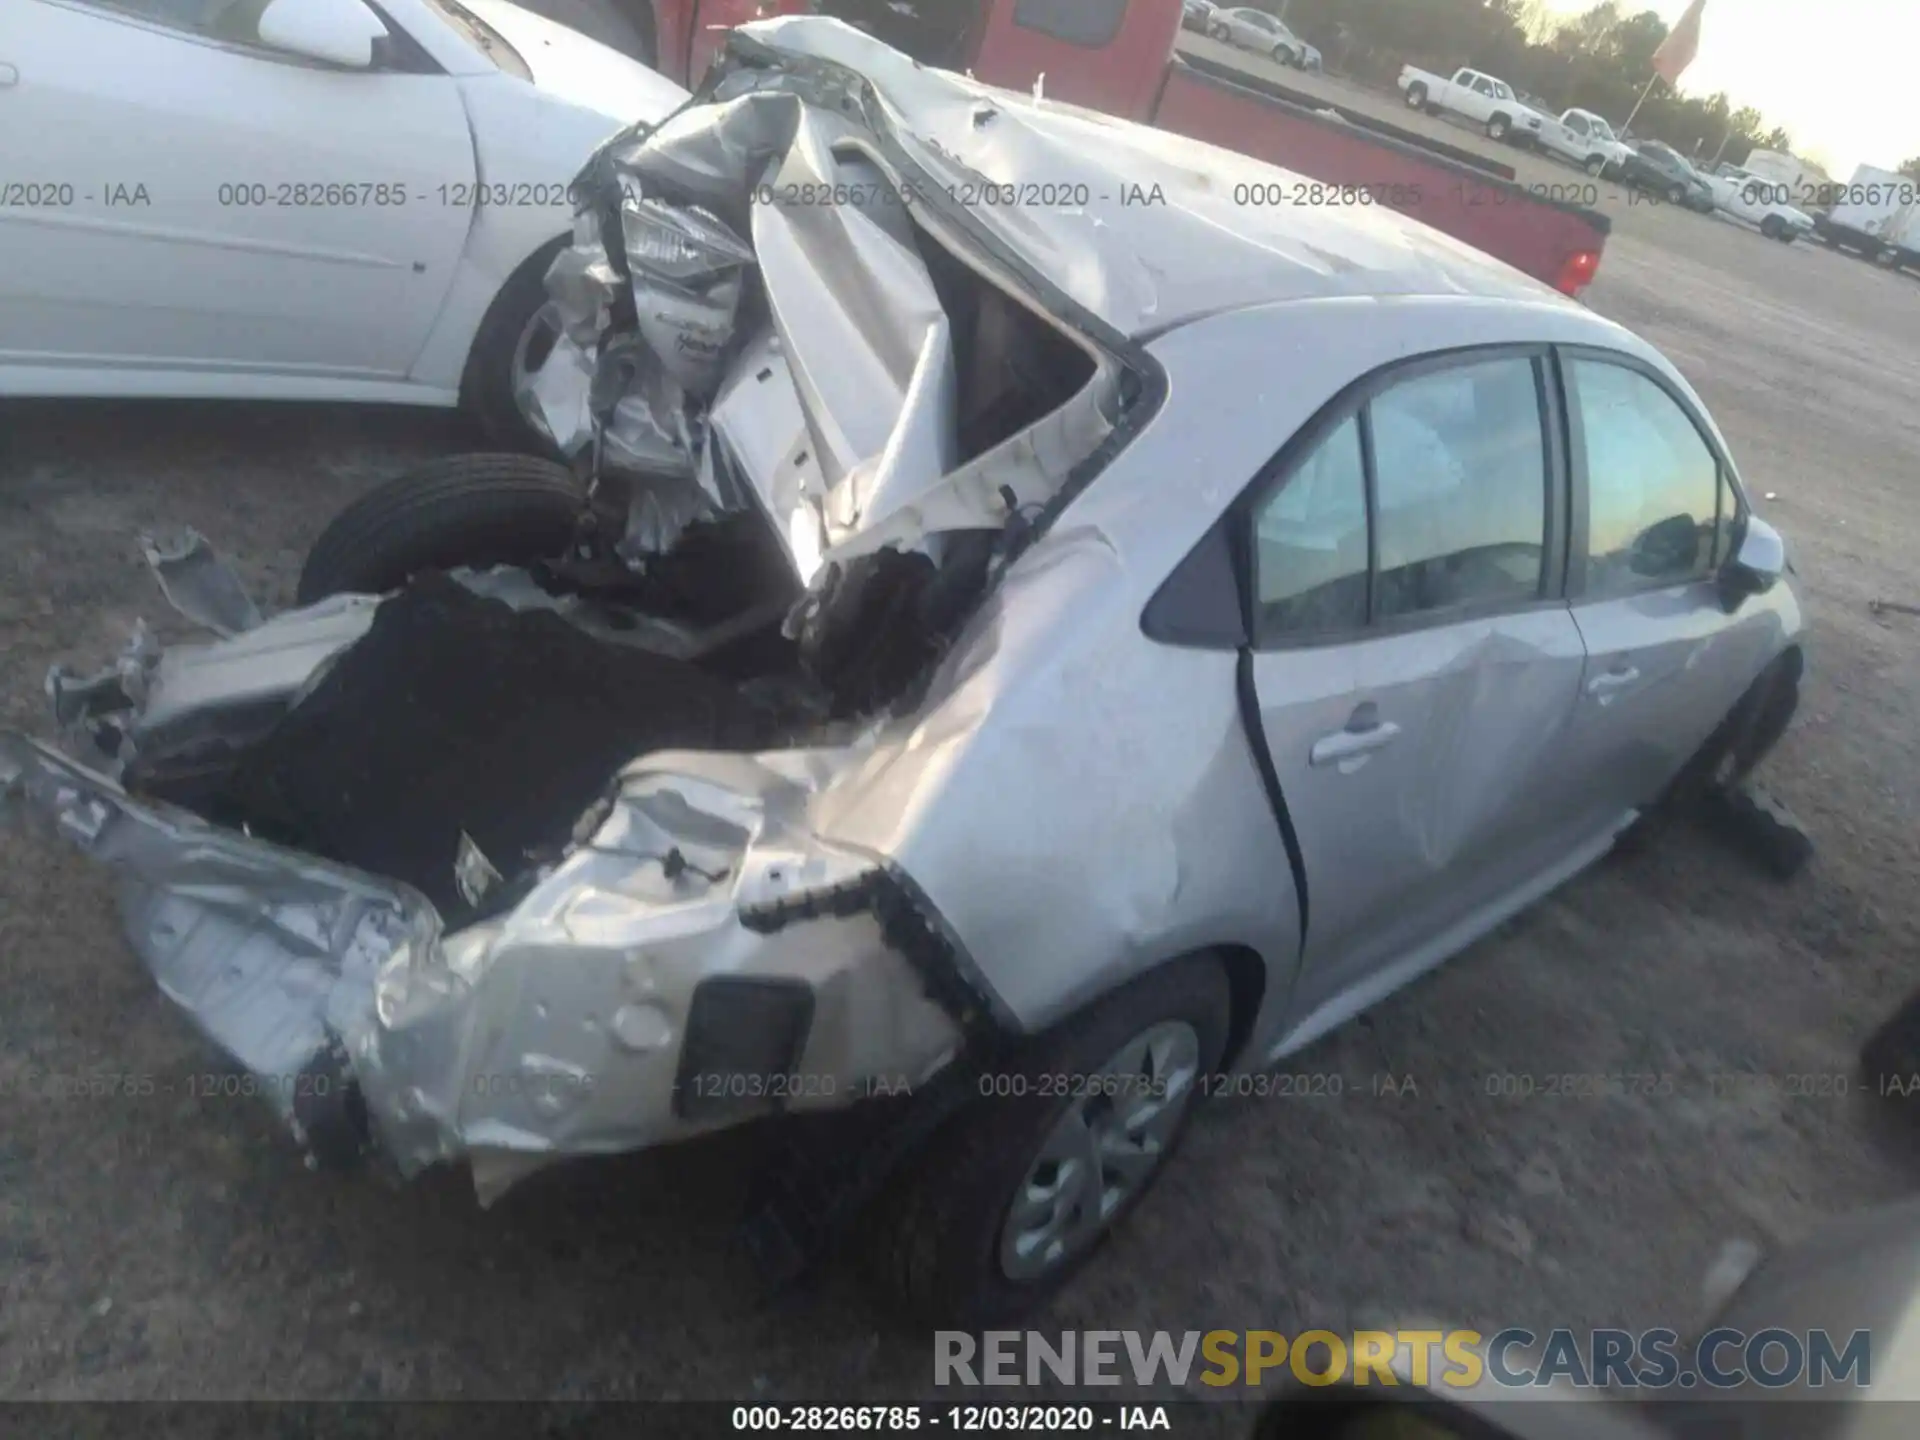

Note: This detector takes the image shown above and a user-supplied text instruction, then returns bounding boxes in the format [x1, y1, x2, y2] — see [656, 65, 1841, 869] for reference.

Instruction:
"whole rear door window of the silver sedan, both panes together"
[1254, 355, 1549, 641]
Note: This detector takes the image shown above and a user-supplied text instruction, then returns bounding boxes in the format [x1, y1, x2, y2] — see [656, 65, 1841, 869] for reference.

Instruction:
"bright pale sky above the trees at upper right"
[1548, 0, 1920, 180]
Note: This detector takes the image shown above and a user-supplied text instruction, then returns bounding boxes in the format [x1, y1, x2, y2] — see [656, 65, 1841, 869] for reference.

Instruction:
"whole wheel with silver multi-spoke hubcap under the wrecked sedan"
[870, 956, 1231, 1329]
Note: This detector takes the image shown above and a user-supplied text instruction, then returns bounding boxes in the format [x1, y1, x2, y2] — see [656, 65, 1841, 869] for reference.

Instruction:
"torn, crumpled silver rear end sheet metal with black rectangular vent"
[0, 733, 962, 1200]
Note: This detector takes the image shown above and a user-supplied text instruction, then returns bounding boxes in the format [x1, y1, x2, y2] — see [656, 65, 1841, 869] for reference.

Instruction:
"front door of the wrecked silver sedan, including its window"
[1561, 349, 1772, 824]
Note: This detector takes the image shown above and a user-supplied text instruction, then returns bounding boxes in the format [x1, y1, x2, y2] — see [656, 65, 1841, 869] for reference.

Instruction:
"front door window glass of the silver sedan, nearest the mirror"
[1571, 359, 1720, 597]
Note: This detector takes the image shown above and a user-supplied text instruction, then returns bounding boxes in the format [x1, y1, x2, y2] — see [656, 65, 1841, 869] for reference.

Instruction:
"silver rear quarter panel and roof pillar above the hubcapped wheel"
[791, 317, 1350, 1041]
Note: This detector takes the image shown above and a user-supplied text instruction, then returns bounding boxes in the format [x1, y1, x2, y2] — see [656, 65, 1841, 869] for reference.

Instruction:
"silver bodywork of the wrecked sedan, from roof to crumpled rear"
[0, 21, 1801, 1194]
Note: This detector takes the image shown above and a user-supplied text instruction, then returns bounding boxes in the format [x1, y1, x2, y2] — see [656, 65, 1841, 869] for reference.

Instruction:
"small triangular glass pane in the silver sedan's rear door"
[1254, 417, 1367, 636]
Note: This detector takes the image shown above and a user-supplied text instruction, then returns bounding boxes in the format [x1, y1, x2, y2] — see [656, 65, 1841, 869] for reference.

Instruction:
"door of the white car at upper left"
[0, 0, 474, 394]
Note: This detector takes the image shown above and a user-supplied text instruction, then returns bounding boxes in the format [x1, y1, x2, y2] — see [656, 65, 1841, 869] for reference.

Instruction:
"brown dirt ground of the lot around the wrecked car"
[0, 42, 1920, 1400]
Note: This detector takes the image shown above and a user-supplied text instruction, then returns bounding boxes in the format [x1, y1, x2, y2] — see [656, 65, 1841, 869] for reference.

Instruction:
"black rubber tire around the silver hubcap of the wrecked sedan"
[866, 956, 1231, 1329]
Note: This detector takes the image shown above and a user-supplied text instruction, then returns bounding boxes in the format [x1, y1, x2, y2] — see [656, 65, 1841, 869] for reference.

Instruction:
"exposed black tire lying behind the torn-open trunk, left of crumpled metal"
[296, 455, 586, 605]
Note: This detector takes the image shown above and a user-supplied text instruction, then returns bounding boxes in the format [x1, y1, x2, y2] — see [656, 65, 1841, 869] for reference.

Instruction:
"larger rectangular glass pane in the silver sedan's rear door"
[1369, 359, 1548, 618]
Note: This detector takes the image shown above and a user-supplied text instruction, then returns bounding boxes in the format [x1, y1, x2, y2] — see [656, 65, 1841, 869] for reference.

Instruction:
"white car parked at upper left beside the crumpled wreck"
[0, 0, 685, 440]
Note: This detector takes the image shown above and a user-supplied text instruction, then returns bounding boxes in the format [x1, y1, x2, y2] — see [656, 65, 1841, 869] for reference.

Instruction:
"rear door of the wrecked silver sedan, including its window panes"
[1248, 349, 1584, 1014]
